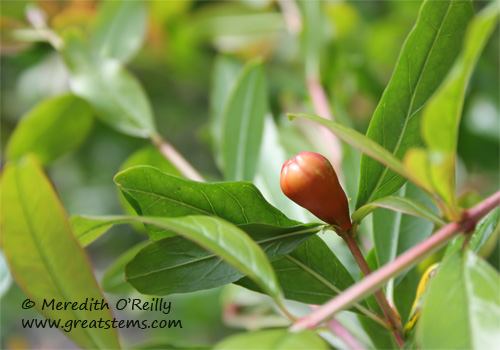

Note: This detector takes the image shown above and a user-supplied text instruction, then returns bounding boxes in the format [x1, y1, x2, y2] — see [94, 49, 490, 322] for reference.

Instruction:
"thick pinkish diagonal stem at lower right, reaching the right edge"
[291, 191, 500, 332]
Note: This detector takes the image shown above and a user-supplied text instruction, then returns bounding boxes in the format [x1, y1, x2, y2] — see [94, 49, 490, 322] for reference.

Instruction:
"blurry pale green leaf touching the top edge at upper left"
[91, 1, 146, 62]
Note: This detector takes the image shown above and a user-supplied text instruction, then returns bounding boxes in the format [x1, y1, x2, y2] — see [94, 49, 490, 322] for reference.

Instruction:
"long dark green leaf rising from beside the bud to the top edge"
[356, 0, 473, 208]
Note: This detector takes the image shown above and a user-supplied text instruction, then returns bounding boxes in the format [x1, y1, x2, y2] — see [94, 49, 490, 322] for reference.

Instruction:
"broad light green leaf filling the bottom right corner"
[417, 251, 500, 349]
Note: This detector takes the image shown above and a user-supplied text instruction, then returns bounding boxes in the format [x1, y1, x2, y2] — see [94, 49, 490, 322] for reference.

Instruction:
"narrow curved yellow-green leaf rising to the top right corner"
[422, 2, 499, 217]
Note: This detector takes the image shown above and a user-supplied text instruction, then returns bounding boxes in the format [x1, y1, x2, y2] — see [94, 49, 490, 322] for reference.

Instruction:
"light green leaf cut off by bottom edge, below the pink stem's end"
[213, 329, 329, 350]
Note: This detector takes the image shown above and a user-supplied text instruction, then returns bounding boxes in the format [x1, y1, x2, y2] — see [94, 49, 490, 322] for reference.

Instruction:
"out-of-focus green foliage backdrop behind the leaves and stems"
[0, 0, 500, 347]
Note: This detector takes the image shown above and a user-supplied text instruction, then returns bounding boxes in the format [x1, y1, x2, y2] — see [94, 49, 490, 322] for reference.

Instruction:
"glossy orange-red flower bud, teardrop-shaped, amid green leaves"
[280, 152, 352, 231]
